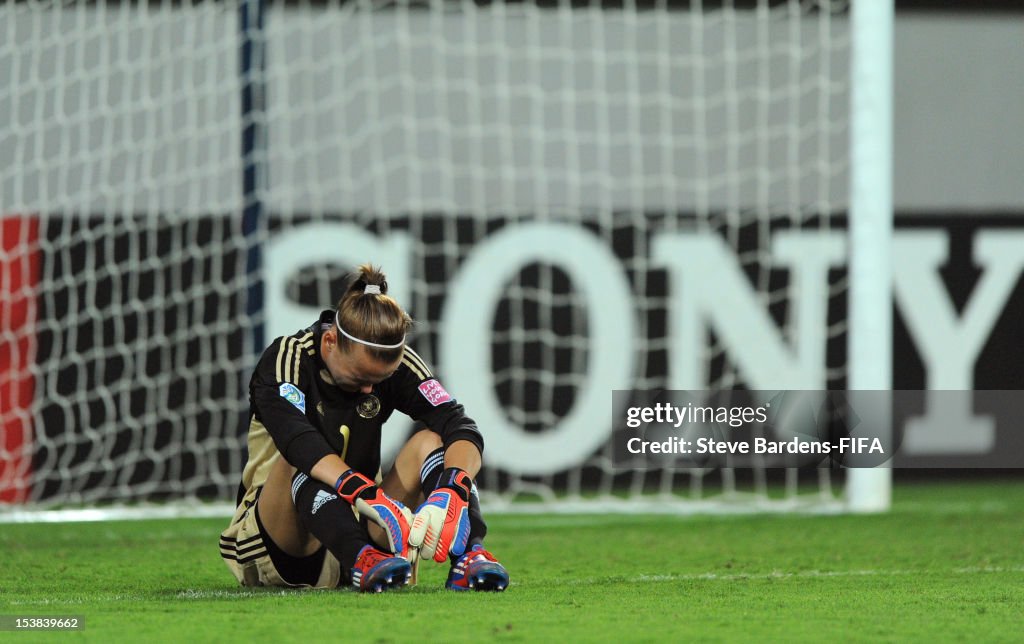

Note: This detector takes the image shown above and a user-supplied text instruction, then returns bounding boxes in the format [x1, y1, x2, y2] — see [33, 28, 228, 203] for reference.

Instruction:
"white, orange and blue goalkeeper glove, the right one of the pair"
[409, 467, 473, 563]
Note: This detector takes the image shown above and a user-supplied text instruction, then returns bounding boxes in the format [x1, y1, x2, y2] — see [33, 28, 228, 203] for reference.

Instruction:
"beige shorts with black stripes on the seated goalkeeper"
[220, 487, 341, 588]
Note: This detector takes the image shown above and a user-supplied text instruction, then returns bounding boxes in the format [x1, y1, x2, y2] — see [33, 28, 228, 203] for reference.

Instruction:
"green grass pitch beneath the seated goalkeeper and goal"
[0, 483, 1024, 642]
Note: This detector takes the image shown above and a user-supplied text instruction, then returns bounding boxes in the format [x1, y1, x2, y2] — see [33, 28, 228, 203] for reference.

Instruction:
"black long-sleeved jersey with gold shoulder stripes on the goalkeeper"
[240, 310, 483, 498]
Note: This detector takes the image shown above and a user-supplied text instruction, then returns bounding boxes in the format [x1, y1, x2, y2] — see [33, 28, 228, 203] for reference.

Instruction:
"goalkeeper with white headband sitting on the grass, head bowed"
[220, 265, 509, 592]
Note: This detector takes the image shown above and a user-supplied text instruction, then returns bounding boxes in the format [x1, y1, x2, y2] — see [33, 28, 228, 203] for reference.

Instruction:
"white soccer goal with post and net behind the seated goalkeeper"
[0, 0, 893, 521]
